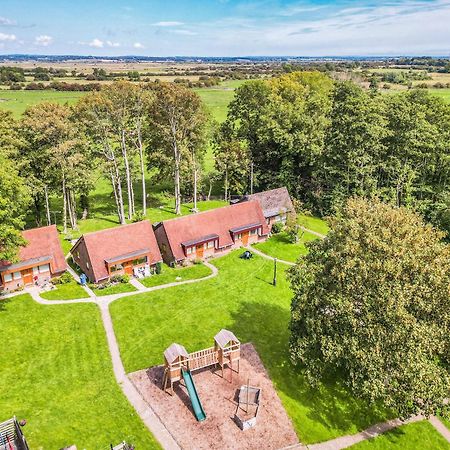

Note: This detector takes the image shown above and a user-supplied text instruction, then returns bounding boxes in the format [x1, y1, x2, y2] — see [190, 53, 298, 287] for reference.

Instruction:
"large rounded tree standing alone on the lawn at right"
[290, 199, 450, 417]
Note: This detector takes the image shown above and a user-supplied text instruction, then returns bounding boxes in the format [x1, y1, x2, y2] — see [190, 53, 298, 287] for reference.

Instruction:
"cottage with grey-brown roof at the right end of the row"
[234, 187, 295, 227]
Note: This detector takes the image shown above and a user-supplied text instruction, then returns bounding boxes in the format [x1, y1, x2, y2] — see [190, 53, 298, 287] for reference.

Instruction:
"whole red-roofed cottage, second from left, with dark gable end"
[70, 220, 162, 283]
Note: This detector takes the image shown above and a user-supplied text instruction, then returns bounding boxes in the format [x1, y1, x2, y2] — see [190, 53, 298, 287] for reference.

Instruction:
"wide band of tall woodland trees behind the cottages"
[0, 72, 450, 256]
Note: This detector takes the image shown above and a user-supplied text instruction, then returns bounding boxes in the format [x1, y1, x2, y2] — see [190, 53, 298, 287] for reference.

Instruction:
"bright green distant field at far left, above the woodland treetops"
[0, 90, 85, 118]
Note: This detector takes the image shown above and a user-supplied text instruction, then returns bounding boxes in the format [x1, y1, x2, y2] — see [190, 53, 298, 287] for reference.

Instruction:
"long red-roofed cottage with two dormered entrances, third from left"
[154, 201, 269, 264]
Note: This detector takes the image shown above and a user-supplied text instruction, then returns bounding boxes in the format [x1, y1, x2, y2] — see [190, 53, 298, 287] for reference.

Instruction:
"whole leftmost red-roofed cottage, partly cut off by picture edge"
[0, 225, 67, 291]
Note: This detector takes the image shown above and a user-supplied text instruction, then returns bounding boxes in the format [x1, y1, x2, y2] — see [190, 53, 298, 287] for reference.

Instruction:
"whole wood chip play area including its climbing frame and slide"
[129, 336, 298, 450]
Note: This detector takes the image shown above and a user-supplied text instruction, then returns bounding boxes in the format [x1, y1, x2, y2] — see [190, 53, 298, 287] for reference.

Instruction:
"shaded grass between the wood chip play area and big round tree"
[231, 302, 387, 443]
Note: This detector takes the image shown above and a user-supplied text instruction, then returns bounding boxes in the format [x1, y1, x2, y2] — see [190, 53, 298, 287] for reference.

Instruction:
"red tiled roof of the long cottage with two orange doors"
[162, 201, 269, 261]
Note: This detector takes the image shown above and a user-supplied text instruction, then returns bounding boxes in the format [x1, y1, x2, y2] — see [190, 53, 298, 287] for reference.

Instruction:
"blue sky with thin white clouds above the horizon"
[0, 0, 450, 56]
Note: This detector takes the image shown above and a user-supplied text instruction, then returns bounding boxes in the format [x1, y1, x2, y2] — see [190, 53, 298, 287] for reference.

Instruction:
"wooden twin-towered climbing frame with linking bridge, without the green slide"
[163, 329, 241, 395]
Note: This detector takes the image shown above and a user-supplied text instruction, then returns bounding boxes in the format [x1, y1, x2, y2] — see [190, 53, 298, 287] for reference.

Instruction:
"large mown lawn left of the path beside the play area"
[0, 295, 157, 450]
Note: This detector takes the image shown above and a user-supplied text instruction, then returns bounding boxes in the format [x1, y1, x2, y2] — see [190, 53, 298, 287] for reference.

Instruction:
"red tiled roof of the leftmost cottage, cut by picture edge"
[0, 225, 67, 273]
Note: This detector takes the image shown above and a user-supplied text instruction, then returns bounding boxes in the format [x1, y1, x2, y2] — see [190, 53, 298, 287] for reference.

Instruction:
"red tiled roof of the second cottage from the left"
[71, 220, 162, 280]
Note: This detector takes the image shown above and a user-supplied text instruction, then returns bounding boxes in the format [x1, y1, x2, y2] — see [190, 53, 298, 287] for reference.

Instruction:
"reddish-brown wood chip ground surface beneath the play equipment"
[129, 344, 298, 450]
